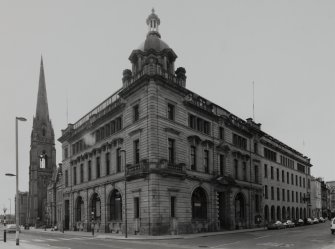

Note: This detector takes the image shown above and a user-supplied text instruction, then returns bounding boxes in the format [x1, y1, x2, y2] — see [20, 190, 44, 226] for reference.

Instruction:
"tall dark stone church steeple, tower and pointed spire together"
[27, 58, 56, 226]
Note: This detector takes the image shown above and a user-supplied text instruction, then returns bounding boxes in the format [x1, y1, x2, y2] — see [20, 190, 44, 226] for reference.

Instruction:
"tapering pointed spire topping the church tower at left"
[36, 55, 49, 122]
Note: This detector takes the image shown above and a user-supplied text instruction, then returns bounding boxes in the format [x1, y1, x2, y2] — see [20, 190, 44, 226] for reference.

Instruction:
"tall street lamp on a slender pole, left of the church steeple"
[10, 117, 27, 246]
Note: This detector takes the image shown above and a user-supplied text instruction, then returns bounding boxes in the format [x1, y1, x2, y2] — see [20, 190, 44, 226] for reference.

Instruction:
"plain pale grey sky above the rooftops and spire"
[0, 0, 335, 213]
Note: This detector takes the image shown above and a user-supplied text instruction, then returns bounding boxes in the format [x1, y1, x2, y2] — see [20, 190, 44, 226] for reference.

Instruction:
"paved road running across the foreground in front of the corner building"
[0, 222, 335, 249]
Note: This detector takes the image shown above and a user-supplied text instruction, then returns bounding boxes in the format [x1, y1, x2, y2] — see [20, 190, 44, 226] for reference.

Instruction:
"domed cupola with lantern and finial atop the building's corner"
[122, 9, 186, 87]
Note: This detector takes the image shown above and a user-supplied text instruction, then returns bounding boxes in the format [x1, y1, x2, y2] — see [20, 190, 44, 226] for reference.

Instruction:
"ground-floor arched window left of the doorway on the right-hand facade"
[192, 187, 207, 219]
